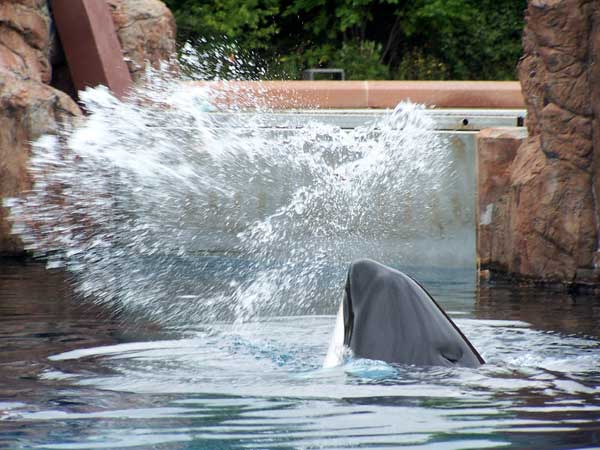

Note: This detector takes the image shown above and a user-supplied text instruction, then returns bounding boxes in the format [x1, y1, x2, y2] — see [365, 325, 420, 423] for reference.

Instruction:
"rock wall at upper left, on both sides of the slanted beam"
[0, 0, 175, 256]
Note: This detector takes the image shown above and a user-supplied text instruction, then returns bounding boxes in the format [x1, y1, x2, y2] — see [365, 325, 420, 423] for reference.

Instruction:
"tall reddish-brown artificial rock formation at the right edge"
[478, 0, 600, 286]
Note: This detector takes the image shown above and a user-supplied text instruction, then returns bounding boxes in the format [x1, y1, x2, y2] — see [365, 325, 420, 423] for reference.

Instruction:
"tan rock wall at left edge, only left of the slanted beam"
[0, 0, 81, 255]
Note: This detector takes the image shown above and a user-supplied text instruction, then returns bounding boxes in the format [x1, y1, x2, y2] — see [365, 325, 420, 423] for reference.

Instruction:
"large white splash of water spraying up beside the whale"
[6, 69, 452, 323]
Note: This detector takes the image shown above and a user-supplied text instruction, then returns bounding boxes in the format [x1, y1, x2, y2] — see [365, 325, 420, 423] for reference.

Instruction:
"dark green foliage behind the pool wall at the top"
[166, 0, 526, 80]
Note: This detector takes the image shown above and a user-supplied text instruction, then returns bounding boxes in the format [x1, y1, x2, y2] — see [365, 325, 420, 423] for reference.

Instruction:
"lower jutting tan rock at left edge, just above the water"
[0, 74, 81, 255]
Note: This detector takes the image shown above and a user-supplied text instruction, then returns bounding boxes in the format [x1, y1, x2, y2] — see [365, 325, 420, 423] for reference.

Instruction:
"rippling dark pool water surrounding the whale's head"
[0, 261, 600, 450]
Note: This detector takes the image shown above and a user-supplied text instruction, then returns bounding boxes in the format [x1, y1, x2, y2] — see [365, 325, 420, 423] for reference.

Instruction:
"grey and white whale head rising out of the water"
[324, 259, 485, 368]
